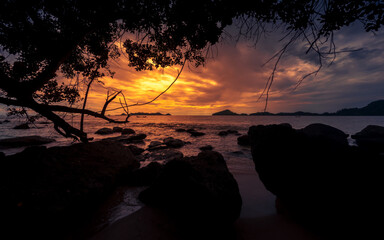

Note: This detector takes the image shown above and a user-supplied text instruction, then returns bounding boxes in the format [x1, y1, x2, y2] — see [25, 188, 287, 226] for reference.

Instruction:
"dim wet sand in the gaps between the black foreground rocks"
[91, 173, 319, 240]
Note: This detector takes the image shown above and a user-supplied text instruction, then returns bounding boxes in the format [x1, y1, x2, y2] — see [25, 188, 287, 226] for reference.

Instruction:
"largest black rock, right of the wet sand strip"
[248, 125, 384, 239]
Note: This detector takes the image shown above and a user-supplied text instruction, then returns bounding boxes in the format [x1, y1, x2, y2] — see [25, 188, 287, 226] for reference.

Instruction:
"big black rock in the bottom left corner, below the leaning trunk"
[0, 141, 139, 239]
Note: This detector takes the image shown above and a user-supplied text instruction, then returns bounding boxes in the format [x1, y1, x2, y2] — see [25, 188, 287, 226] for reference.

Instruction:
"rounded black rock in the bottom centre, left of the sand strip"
[139, 151, 242, 239]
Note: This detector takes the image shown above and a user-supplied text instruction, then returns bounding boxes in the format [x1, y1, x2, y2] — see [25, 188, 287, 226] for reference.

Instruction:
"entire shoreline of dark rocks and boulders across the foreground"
[0, 124, 384, 239]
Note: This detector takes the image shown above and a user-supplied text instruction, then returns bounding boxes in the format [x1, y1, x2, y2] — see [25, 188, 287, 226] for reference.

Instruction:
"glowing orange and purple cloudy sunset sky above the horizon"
[70, 24, 384, 115]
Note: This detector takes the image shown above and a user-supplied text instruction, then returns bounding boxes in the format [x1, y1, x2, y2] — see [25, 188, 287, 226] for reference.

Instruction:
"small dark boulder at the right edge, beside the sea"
[351, 125, 384, 152]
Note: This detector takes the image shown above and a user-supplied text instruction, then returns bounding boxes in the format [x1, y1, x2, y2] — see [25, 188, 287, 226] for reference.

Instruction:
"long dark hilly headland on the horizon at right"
[212, 100, 384, 116]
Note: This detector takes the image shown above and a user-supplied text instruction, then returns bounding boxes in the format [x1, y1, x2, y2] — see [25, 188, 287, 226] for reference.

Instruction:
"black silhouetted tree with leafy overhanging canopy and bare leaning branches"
[0, 0, 384, 142]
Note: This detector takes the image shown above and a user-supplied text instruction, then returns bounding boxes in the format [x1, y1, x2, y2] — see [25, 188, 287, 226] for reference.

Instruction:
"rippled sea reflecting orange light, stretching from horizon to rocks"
[0, 115, 384, 172]
